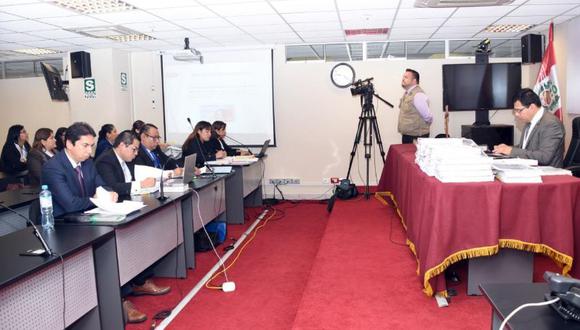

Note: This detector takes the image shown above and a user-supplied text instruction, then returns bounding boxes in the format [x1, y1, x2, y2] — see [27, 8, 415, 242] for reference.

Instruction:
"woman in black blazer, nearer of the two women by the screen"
[181, 121, 226, 168]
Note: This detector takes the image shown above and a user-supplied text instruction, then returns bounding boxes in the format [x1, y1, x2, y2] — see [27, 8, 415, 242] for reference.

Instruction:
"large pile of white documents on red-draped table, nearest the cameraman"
[415, 138, 494, 182]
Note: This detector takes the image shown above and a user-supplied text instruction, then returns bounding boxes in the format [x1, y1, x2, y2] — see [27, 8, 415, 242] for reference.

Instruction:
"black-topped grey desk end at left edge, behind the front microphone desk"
[0, 187, 39, 236]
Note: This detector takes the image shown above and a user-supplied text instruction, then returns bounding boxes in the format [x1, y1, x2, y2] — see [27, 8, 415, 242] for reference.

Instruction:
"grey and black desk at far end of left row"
[211, 158, 264, 224]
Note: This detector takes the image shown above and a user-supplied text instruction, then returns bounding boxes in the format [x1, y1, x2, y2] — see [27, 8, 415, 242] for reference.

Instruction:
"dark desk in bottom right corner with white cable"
[480, 283, 580, 330]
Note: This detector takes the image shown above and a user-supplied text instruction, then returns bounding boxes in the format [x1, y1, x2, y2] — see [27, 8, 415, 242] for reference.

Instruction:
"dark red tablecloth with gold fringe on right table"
[377, 144, 580, 295]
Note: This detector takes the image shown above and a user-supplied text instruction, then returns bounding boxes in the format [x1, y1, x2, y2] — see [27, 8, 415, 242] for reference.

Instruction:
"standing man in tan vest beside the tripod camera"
[398, 69, 433, 143]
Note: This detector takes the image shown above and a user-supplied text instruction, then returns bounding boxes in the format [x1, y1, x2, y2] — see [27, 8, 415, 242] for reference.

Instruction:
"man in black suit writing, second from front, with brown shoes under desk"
[96, 131, 171, 323]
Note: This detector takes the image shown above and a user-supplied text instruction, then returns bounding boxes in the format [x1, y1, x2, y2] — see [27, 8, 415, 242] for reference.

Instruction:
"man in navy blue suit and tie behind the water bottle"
[42, 122, 118, 217]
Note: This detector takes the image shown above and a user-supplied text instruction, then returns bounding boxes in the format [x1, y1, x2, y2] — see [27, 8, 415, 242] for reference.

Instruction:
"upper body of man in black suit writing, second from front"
[95, 130, 155, 195]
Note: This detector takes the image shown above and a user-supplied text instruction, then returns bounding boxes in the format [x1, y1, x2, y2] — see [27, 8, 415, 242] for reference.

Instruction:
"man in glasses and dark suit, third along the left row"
[134, 124, 183, 176]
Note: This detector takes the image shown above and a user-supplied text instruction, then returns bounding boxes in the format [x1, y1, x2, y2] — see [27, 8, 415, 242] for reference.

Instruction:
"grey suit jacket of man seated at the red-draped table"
[510, 110, 565, 167]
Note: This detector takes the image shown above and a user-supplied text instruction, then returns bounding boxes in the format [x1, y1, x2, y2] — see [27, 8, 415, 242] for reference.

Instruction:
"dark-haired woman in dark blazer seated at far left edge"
[1, 125, 30, 174]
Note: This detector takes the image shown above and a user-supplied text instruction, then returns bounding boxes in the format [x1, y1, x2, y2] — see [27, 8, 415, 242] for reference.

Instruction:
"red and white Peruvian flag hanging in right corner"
[534, 23, 562, 121]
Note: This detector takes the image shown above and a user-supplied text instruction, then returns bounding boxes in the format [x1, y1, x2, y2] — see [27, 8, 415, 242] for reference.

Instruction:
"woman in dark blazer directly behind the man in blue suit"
[27, 128, 56, 186]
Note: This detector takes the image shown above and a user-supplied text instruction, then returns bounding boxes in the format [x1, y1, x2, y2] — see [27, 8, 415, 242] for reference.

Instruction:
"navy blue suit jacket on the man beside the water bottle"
[42, 150, 105, 217]
